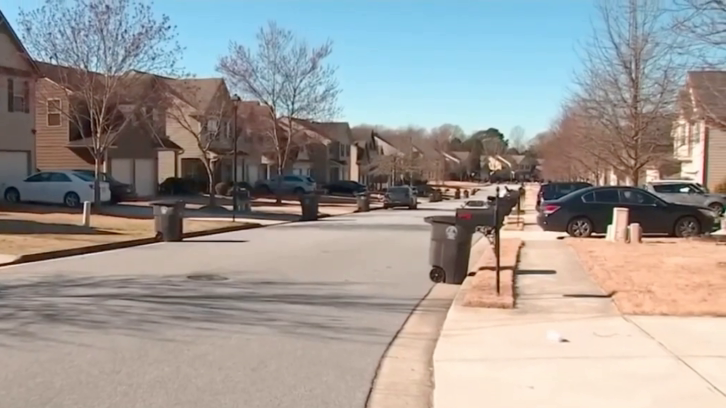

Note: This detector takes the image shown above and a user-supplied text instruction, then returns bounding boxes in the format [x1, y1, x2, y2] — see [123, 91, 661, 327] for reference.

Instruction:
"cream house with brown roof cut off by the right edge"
[671, 71, 726, 189]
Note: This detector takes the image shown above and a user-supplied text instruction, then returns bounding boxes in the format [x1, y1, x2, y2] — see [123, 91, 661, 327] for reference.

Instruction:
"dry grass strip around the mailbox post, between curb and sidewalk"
[462, 238, 523, 309]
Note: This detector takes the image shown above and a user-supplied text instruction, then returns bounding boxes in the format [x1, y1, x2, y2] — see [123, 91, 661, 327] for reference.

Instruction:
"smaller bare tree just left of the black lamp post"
[165, 79, 239, 205]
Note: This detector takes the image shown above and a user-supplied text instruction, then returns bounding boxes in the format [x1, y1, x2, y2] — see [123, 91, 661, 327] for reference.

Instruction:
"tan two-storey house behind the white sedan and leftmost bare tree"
[35, 61, 179, 197]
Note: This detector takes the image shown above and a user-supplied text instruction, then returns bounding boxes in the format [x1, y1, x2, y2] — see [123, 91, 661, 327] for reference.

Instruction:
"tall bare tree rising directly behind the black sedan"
[577, 0, 684, 184]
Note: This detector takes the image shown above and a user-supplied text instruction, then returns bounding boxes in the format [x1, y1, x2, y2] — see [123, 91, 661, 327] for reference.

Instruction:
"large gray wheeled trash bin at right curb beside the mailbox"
[424, 215, 473, 285]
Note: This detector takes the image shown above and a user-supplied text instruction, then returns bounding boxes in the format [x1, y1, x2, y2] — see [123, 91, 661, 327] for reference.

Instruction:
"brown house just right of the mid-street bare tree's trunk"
[292, 119, 358, 183]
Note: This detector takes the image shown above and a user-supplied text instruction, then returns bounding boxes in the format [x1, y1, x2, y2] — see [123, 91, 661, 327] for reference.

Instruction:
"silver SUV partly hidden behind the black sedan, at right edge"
[645, 180, 726, 214]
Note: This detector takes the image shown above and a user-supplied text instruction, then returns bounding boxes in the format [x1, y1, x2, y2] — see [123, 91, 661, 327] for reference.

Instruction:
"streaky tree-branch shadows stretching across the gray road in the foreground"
[0, 274, 426, 347]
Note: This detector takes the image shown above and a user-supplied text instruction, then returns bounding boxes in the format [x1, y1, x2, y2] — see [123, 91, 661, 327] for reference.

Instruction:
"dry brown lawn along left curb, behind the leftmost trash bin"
[0, 211, 242, 255]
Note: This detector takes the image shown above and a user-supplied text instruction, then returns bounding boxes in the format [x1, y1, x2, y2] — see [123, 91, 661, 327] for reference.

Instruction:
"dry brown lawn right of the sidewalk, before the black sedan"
[566, 238, 726, 316]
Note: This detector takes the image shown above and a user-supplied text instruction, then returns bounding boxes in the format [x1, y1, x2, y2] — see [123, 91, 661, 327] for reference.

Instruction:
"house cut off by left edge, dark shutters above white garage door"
[0, 12, 38, 191]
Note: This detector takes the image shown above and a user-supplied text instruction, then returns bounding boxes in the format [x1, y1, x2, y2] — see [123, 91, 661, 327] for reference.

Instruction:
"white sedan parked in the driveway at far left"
[3, 170, 111, 207]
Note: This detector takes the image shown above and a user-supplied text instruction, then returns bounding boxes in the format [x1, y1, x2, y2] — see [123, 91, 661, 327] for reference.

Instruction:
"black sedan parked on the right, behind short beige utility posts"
[537, 186, 718, 237]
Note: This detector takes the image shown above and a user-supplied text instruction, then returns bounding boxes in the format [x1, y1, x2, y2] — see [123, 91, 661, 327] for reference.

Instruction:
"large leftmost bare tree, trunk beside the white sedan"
[18, 0, 182, 203]
